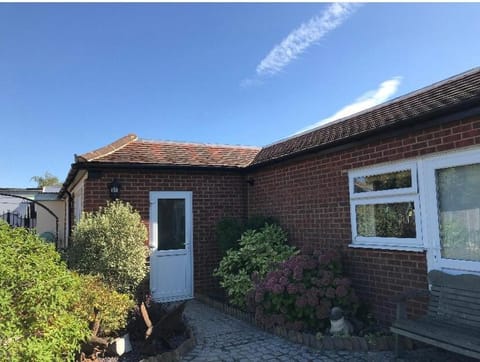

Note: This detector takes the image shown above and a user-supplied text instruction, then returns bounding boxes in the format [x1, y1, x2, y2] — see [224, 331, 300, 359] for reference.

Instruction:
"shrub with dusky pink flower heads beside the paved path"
[248, 251, 358, 332]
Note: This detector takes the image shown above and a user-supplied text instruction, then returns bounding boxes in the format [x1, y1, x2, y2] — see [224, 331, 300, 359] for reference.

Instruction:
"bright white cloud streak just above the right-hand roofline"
[294, 77, 402, 135]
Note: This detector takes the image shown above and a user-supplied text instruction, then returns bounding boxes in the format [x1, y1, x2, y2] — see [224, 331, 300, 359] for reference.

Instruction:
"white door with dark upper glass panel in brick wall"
[150, 191, 193, 302]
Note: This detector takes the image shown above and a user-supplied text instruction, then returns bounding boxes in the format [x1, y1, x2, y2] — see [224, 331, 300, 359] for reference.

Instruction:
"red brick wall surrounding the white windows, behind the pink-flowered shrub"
[248, 119, 480, 322]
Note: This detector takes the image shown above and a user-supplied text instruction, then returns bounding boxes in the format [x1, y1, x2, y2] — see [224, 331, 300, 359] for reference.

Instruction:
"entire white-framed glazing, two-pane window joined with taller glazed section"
[348, 147, 480, 273]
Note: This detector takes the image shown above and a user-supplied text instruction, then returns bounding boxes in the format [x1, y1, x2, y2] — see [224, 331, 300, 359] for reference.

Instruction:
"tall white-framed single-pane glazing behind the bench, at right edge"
[421, 150, 480, 273]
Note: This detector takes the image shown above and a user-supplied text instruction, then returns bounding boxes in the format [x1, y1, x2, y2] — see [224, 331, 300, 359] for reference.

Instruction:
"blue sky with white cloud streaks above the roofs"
[0, 3, 480, 187]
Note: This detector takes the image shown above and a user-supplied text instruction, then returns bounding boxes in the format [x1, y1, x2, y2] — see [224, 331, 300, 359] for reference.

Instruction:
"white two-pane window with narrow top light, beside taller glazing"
[349, 162, 423, 250]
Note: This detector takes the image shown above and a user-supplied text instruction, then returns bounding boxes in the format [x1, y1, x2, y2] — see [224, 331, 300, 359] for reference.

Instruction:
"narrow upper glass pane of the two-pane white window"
[353, 170, 412, 193]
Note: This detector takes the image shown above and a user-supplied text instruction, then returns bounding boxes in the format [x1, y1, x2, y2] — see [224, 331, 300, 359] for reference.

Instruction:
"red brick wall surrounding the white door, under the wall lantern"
[84, 169, 246, 292]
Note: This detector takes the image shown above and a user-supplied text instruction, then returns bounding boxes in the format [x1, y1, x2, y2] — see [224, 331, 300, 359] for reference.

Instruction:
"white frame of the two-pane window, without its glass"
[348, 161, 424, 251]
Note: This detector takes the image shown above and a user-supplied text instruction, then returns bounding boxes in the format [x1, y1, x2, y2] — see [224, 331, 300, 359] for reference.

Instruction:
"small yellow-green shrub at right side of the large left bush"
[75, 275, 135, 337]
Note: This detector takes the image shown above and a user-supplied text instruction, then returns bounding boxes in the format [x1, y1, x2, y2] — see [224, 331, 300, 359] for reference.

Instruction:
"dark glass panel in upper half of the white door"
[157, 199, 185, 250]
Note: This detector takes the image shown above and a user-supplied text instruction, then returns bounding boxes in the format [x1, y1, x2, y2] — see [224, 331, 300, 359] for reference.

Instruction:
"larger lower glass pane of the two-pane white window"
[355, 201, 417, 238]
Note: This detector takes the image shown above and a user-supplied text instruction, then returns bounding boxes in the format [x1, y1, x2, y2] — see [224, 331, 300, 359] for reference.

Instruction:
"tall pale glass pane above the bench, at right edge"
[436, 164, 480, 261]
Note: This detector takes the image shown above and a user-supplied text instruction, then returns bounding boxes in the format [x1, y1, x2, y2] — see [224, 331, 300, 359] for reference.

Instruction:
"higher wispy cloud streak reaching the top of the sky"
[256, 3, 358, 76]
